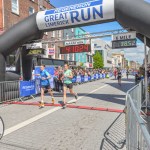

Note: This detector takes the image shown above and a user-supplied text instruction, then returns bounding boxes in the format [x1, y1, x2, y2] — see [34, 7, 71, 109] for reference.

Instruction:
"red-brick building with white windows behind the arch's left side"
[0, 0, 63, 64]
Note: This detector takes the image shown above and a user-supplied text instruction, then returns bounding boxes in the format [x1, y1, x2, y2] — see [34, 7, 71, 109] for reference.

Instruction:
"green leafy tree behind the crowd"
[93, 51, 104, 69]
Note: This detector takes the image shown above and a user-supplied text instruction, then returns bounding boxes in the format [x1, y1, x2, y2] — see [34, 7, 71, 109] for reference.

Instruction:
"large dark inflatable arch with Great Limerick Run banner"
[0, 0, 150, 81]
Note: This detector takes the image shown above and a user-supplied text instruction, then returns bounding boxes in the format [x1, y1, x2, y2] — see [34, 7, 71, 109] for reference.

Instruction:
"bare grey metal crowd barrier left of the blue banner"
[0, 81, 20, 102]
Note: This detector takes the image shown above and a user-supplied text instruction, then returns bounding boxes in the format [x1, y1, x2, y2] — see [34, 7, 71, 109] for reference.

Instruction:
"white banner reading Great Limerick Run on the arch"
[36, 0, 115, 30]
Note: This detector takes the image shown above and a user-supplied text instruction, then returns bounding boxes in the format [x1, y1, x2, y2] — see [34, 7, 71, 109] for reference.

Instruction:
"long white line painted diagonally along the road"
[4, 82, 108, 136]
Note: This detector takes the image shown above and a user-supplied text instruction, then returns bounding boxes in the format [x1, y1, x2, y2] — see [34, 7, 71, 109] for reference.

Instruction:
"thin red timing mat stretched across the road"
[5, 102, 124, 113]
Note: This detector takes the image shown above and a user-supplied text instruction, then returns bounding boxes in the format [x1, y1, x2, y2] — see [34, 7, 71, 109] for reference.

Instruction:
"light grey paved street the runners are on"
[0, 76, 134, 150]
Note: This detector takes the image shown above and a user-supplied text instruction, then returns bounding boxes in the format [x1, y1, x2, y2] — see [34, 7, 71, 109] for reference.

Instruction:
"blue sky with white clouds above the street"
[50, 0, 144, 64]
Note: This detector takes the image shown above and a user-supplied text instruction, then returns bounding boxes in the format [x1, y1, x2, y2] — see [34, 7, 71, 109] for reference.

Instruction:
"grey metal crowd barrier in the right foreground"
[126, 81, 150, 150]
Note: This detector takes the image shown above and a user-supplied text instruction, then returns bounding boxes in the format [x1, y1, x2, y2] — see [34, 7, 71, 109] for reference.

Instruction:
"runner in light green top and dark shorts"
[63, 64, 78, 107]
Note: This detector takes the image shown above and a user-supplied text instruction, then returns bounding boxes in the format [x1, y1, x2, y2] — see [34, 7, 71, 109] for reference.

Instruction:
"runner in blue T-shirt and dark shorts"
[36, 65, 54, 108]
